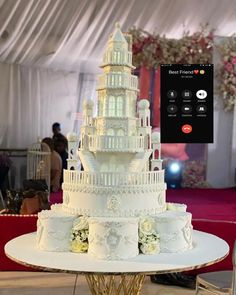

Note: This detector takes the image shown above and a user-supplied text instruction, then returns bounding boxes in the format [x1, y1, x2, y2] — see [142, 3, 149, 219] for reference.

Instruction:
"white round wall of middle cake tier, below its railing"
[63, 186, 166, 217]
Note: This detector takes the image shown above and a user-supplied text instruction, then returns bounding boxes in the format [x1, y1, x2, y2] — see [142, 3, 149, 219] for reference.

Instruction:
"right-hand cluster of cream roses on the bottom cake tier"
[139, 217, 160, 254]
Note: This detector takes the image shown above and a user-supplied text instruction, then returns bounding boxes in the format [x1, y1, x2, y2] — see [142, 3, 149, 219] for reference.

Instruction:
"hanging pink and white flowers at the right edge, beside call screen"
[218, 35, 236, 111]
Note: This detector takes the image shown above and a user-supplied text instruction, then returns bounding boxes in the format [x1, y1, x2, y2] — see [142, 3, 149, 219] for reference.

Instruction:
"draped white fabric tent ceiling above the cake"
[0, 0, 236, 72]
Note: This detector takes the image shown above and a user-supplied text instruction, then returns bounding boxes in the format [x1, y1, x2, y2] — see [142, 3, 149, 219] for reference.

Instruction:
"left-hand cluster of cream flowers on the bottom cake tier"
[70, 216, 89, 253]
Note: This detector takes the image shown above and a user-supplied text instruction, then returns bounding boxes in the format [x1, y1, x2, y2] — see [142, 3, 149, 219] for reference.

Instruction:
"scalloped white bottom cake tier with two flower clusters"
[37, 203, 192, 260]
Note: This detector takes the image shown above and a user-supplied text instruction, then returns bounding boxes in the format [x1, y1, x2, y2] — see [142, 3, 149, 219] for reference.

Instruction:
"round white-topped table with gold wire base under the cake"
[5, 230, 229, 295]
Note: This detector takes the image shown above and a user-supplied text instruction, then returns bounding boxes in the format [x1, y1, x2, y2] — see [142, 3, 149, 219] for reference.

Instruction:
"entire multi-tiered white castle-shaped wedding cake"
[37, 25, 192, 260]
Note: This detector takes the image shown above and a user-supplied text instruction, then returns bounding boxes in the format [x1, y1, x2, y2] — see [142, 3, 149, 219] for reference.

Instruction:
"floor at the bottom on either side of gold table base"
[0, 272, 195, 295]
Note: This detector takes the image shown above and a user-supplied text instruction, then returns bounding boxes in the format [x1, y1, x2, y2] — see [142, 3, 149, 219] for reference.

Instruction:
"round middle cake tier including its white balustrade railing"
[63, 170, 166, 217]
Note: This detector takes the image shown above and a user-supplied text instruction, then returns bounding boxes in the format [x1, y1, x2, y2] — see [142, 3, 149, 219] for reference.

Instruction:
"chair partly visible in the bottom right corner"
[196, 241, 236, 295]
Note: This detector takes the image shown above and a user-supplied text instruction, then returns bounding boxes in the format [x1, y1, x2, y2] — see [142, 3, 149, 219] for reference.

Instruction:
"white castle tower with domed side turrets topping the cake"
[68, 23, 162, 172]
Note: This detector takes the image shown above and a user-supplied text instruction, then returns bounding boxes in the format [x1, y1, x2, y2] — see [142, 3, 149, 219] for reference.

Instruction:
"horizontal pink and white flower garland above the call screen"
[129, 25, 213, 69]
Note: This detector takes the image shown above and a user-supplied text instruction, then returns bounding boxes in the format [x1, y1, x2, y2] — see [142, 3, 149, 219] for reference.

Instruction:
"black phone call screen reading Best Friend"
[160, 64, 213, 143]
